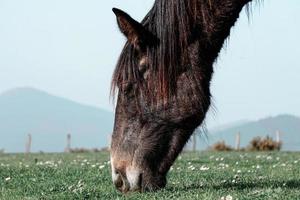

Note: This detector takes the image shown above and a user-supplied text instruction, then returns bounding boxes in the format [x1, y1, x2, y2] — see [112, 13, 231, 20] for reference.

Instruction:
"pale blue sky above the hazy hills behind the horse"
[0, 0, 300, 126]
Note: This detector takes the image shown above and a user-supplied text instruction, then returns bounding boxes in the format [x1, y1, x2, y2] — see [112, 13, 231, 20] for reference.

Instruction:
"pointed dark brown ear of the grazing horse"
[113, 8, 150, 49]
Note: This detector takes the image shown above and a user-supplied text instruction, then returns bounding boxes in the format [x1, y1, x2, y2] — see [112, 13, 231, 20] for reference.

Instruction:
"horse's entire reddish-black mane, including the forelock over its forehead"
[111, 0, 261, 103]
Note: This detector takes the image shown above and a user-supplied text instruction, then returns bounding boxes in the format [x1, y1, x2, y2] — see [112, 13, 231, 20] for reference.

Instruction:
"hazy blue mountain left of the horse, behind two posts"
[0, 88, 113, 152]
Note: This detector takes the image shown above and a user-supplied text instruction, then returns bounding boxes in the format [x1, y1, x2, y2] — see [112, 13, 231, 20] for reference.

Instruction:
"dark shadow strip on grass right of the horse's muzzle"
[165, 180, 300, 192]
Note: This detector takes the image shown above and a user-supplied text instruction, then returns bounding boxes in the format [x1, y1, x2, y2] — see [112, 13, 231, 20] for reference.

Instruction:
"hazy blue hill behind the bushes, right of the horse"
[208, 115, 300, 151]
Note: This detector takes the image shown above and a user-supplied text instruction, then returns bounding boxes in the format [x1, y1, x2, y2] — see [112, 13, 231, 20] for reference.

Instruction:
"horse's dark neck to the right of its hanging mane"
[190, 0, 251, 63]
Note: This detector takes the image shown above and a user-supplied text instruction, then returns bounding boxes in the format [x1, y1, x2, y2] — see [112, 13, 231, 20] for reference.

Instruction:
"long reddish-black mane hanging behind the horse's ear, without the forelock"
[142, 0, 202, 101]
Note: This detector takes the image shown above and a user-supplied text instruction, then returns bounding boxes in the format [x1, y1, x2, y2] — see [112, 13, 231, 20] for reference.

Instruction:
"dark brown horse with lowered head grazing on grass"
[111, 0, 251, 193]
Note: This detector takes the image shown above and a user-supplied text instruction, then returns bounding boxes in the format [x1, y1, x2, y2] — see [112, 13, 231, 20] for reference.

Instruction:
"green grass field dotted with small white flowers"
[0, 152, 300, 200]
